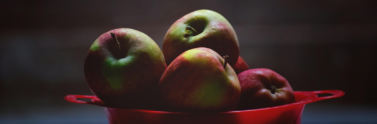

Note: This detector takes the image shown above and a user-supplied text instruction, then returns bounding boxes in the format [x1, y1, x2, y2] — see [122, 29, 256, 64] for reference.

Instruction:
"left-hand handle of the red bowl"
[64, 95, 105, 106]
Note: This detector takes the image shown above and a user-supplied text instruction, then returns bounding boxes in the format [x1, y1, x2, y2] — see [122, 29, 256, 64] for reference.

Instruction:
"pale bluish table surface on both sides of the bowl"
[0, 104, 377, 124]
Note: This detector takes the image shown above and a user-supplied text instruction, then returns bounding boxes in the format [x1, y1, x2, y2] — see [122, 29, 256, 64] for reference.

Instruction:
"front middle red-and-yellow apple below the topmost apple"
[159, 47, 241, 113]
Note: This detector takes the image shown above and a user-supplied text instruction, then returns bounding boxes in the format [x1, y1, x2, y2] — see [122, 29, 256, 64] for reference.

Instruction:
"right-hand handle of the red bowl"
[312, 90, 345, 102]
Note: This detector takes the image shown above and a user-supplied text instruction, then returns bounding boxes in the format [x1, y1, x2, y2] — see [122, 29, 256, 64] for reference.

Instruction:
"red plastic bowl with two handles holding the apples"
[65, 90, 344, 124]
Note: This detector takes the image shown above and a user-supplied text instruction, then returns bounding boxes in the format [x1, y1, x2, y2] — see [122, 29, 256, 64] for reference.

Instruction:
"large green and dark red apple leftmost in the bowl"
[84, 28, 166, 108]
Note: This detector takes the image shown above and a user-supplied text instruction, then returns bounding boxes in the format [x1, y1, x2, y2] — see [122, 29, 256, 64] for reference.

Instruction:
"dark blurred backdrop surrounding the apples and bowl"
[0, 0, 377, 124]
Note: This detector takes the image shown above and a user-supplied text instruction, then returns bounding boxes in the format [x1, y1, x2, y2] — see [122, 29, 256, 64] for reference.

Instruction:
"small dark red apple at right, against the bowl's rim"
[237, 68, 296, 110]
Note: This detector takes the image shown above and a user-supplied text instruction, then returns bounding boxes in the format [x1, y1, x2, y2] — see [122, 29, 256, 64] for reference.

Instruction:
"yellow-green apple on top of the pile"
[162, 9, 239, 66]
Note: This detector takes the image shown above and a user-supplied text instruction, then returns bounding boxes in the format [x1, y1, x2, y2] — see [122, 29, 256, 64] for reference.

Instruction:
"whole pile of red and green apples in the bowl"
[84, 10, 295, 113]
